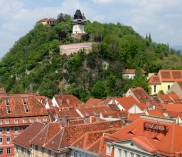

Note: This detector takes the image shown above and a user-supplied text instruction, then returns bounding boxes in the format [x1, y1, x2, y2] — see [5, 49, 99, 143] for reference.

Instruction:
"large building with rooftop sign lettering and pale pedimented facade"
[109, 115, 182, 157]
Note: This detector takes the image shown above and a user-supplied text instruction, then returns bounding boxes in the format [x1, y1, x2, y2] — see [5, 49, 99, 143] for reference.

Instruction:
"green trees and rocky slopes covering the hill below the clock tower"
[0, 14, 182, 101]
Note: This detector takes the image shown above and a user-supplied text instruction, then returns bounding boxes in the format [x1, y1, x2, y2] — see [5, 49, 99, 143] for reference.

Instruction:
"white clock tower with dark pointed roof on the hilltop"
[71, 9, 86, 34]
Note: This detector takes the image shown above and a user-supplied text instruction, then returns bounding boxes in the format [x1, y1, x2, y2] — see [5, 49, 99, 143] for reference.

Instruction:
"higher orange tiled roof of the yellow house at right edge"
[159, 70, 182, 82]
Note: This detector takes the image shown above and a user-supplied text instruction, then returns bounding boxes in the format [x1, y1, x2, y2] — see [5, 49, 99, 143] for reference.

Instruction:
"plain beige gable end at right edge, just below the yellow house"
[167, 81, 182, 99]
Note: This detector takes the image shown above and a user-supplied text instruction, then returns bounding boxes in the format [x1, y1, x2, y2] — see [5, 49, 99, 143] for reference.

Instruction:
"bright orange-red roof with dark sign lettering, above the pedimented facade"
[112, 118, 182, 156]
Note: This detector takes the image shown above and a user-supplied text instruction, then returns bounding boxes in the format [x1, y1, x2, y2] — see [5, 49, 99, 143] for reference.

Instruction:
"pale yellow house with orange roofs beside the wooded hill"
[148, 70, 182, 94]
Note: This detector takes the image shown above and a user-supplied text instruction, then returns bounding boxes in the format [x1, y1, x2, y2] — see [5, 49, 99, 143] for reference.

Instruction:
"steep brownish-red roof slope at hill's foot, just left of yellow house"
[130, 87, 150, 102]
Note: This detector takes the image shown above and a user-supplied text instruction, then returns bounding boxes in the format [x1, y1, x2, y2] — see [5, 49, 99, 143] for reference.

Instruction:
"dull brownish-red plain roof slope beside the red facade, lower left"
[13, 122, 45, 149]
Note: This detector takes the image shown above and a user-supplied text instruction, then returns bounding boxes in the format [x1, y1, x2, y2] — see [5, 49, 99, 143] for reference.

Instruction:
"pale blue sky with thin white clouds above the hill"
[0, 0, 182, 58]
